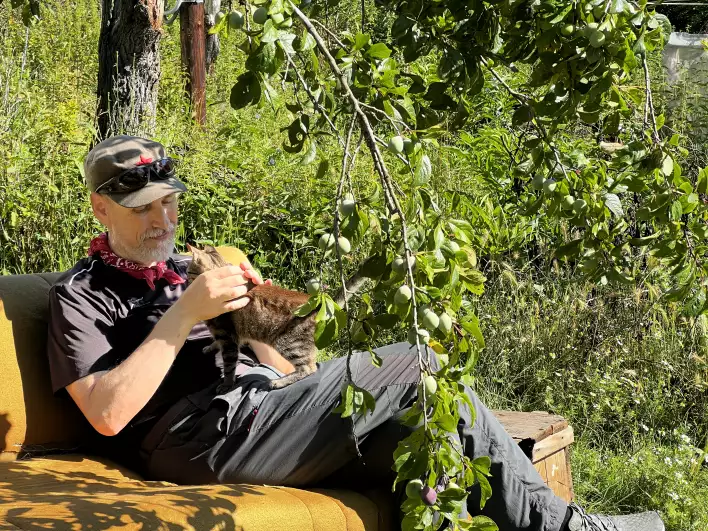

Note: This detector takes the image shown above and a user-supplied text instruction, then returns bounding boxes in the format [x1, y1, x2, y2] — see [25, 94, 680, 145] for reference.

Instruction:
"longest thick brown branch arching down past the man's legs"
[288, 1, 428, 416]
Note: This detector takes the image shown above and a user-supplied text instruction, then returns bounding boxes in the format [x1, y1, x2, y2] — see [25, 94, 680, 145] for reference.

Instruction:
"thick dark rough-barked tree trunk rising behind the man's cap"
[97, 0, 164, 140]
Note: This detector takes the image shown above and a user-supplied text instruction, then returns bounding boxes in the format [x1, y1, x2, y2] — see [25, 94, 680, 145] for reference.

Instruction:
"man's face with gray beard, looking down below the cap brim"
[91, 193, 178, 265]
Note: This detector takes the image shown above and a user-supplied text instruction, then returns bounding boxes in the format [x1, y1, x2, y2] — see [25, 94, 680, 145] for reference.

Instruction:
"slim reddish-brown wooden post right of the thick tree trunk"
[179, 2, 206, 125]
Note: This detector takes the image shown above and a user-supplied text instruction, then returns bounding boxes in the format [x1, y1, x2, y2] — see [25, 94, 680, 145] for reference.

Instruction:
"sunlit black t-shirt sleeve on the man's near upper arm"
[47, 284, 119, 393]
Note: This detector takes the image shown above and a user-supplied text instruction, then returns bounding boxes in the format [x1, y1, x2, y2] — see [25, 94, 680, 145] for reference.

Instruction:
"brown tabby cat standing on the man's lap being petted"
[187, 245, 317, 392]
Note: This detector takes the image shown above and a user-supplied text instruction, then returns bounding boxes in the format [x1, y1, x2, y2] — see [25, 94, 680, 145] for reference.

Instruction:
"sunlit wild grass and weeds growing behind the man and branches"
[0, 0, 708, 531]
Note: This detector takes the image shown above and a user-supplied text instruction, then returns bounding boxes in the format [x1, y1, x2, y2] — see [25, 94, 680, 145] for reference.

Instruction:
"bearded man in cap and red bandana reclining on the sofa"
[48, 136, 664, 531]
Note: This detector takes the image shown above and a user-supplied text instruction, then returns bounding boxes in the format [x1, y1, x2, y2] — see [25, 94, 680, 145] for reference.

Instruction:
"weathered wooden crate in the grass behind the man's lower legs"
[494, 411, 574, 502]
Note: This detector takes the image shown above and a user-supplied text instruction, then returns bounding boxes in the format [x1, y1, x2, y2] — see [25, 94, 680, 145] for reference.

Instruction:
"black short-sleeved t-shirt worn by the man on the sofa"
[47, 255, 255, 470]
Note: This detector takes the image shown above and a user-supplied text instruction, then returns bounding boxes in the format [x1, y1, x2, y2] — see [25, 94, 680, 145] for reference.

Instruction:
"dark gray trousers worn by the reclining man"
[143, 343, 567, 531]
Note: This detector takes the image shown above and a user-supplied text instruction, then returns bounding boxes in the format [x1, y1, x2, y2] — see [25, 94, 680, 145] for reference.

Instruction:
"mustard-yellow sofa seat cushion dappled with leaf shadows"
[0, 455, 391, 531]
